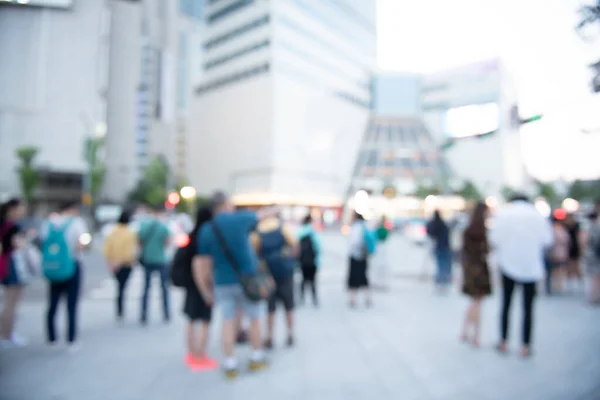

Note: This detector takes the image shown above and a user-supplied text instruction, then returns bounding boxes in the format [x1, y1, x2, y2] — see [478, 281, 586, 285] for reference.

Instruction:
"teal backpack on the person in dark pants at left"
[42, 219, 75, 282]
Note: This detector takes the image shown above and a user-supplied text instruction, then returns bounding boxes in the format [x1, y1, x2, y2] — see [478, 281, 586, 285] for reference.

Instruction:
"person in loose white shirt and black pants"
[490, 195, 553, 357]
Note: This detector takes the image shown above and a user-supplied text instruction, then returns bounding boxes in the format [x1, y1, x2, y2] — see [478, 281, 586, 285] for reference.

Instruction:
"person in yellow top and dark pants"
[104, 211, 138, 321]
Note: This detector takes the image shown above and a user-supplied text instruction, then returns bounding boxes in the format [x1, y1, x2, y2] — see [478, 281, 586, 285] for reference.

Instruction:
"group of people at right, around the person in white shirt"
[427, 195, 600, 357]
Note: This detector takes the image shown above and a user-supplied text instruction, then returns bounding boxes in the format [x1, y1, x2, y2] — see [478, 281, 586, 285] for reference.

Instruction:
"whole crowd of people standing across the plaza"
[0, 192, 600, 378]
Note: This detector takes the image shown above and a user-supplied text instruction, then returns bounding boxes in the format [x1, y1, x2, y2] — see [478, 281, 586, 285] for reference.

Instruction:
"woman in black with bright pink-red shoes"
[183, 207, 218, 370]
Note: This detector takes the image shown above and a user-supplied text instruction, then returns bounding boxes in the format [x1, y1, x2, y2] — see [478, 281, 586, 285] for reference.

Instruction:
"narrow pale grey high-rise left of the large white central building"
[104, 0, 204, 201]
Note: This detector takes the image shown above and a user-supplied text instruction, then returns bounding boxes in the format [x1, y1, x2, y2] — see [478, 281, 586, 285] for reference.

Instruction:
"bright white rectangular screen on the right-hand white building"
[444, 103, 500, 138]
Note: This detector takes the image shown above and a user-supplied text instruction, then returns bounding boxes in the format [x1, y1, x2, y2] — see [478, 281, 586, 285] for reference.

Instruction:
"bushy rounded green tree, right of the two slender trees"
[129, 156, 169, 206]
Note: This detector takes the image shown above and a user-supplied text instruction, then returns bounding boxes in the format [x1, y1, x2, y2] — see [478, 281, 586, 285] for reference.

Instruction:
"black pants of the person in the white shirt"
[501, 274, 535, 346]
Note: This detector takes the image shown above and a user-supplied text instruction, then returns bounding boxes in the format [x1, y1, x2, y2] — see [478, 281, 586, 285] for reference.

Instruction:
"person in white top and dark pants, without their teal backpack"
[40, 202, 88, 351]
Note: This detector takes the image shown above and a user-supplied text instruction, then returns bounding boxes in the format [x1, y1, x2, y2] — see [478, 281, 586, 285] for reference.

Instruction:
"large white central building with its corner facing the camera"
[188, 0, 376, 206]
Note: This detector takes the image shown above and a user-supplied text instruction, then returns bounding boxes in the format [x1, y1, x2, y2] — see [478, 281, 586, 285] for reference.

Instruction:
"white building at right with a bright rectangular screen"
[421, 60, 528, 196]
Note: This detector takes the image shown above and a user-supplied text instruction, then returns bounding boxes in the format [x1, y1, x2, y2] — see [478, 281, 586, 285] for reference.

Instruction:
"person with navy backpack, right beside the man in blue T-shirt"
[250, 211, 298, 350]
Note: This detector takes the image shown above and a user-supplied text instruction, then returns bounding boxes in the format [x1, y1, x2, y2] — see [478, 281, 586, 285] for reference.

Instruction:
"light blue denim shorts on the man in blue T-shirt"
[215, 284, 265, 321]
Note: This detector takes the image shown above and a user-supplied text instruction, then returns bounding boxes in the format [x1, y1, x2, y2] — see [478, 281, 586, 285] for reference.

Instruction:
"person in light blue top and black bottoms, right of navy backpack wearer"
[298, 214, 321, 307]
